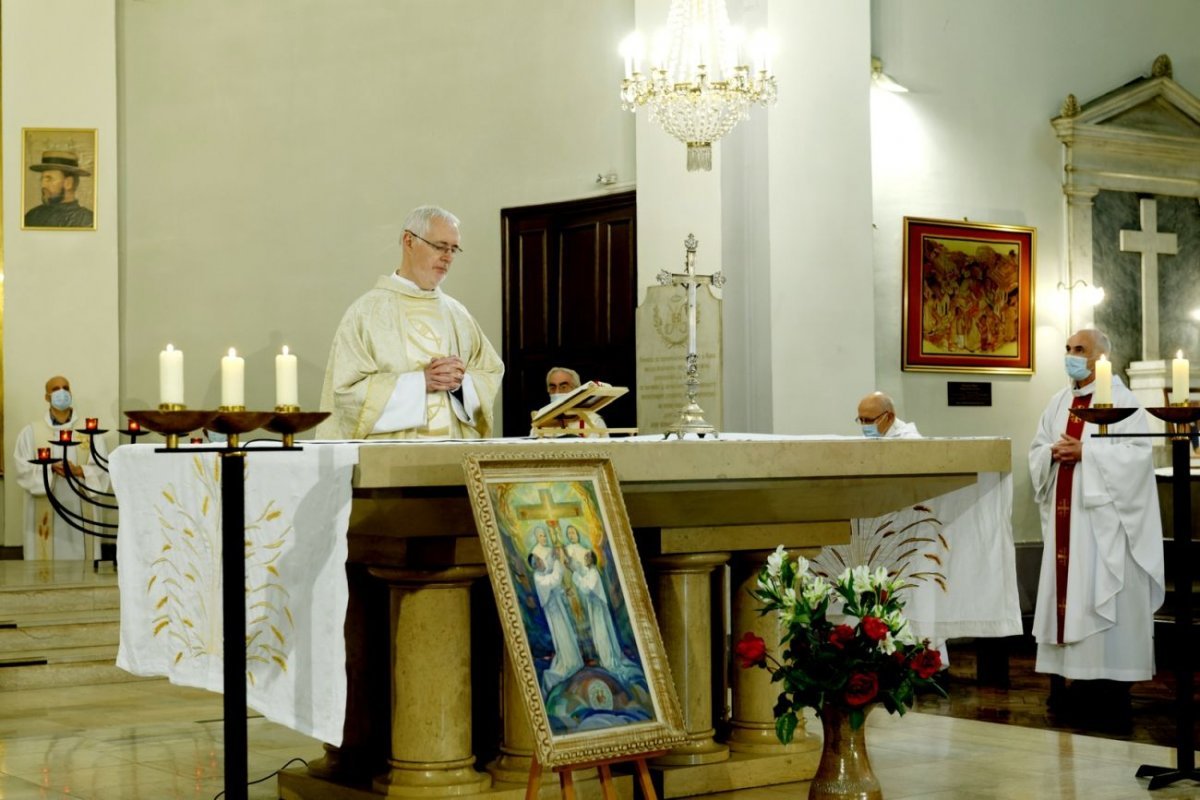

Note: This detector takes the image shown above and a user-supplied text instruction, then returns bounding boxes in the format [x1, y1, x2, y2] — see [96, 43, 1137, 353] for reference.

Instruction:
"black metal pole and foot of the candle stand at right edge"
[1138, 437, 1200, 790]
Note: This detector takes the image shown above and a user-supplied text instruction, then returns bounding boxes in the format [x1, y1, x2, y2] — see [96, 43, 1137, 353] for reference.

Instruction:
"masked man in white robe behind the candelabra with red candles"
[12, 375, 108, 561]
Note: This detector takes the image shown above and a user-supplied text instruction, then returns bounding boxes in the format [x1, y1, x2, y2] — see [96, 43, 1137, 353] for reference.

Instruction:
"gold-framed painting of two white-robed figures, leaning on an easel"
[463, 453, 684, 769]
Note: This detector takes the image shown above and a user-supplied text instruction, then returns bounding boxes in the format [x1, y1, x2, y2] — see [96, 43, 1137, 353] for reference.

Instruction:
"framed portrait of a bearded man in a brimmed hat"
[20, 128, 96, 230]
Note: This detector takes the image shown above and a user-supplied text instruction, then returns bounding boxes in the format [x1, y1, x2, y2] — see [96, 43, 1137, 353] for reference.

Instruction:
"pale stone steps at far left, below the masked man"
[0, 561, 145, 692]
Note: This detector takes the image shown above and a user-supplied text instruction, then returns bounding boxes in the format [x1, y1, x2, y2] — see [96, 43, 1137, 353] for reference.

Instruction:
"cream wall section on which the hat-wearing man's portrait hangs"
[0, 0, 120, 547]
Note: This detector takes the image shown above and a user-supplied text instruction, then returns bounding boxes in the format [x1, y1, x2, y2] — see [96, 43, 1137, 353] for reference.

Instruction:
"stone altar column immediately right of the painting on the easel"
[648, 553, 730, 767]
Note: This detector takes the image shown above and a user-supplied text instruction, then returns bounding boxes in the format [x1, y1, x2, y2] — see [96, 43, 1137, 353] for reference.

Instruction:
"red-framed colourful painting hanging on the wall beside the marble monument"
[901, 217, 1037, 374]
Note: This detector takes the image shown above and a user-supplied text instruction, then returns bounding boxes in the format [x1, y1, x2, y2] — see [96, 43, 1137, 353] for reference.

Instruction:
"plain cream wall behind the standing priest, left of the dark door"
[119, 0, 634, 422]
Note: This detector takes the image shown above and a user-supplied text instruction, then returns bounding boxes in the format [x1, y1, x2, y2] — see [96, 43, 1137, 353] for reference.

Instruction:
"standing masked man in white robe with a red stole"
[1030, 329, 1164, 730]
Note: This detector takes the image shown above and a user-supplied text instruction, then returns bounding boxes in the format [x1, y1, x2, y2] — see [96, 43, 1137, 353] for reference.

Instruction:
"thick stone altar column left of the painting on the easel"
[371, 566, 492, 796]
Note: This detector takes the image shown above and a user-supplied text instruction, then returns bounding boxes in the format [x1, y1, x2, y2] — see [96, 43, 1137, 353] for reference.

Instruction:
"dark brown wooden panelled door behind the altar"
[500, 192, 637, 437]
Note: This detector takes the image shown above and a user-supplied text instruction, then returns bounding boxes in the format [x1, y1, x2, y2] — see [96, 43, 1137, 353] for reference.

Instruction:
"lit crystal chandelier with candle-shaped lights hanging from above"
[620, 0, 775, 172]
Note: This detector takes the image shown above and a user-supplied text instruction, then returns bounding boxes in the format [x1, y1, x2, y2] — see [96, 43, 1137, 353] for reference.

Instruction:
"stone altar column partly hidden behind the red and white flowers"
[728, 548, 820, 754]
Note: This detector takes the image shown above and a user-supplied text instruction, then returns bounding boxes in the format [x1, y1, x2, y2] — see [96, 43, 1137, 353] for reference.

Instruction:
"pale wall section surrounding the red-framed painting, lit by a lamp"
[871, 0, 1200, 541]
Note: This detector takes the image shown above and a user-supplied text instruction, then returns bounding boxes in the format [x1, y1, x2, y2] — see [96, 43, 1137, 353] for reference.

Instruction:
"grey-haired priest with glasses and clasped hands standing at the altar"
[317, 206, 504, 439]
